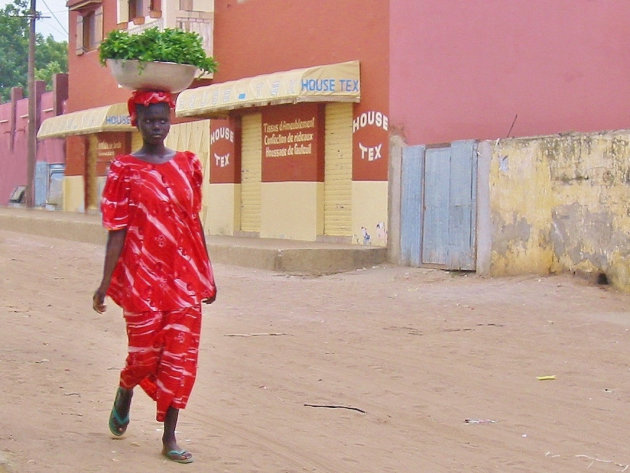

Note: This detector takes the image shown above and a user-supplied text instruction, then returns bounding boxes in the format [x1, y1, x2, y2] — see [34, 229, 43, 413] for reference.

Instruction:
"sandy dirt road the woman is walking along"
[0, 230, 630, 473]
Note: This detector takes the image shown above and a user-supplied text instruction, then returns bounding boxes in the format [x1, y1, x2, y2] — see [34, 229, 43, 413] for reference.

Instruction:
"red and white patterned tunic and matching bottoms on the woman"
[101, 152, 216, 421]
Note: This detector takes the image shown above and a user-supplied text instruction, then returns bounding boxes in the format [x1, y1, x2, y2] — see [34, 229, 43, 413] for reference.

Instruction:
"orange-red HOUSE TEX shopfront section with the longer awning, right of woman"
[176, 0, 389, 246]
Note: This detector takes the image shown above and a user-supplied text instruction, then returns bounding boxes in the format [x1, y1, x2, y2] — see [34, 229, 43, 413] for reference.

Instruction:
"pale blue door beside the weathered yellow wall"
[400, 141, 477, 270]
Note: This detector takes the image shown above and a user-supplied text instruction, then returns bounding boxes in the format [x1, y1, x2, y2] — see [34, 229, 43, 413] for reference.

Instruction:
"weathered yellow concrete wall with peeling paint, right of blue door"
[482, 130, 630, 292]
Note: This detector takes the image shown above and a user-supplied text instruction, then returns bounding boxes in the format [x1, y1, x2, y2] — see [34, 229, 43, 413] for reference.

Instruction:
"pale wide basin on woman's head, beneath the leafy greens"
[107, 59, 197, 93]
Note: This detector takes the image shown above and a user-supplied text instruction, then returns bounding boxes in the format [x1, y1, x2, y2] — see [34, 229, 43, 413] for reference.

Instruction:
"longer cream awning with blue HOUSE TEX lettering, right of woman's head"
[175, 61, 361, 117]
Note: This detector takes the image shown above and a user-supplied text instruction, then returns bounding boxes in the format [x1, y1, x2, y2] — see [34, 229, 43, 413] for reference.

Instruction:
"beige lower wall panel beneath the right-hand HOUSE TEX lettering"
[352, 181, 388, 246]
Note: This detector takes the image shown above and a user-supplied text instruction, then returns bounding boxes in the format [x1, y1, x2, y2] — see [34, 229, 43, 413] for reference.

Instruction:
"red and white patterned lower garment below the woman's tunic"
[120, 305, 201, 422]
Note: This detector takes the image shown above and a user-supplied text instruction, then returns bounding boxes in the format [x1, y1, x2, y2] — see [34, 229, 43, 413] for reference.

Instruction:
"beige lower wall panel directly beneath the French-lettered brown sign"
[260, 182, 324, 241]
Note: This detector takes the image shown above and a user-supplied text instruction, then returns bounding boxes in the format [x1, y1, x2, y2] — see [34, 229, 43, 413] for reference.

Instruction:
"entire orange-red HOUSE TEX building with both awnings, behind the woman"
[40, 0, 389, 246]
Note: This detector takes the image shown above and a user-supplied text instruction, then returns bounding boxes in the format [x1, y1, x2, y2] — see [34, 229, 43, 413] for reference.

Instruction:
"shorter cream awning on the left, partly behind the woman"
[37, 103, 135, 140]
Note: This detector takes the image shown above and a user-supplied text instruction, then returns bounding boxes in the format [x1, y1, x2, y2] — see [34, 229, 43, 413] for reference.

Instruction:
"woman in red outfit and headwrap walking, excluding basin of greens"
[93, 91, 216, 463]
